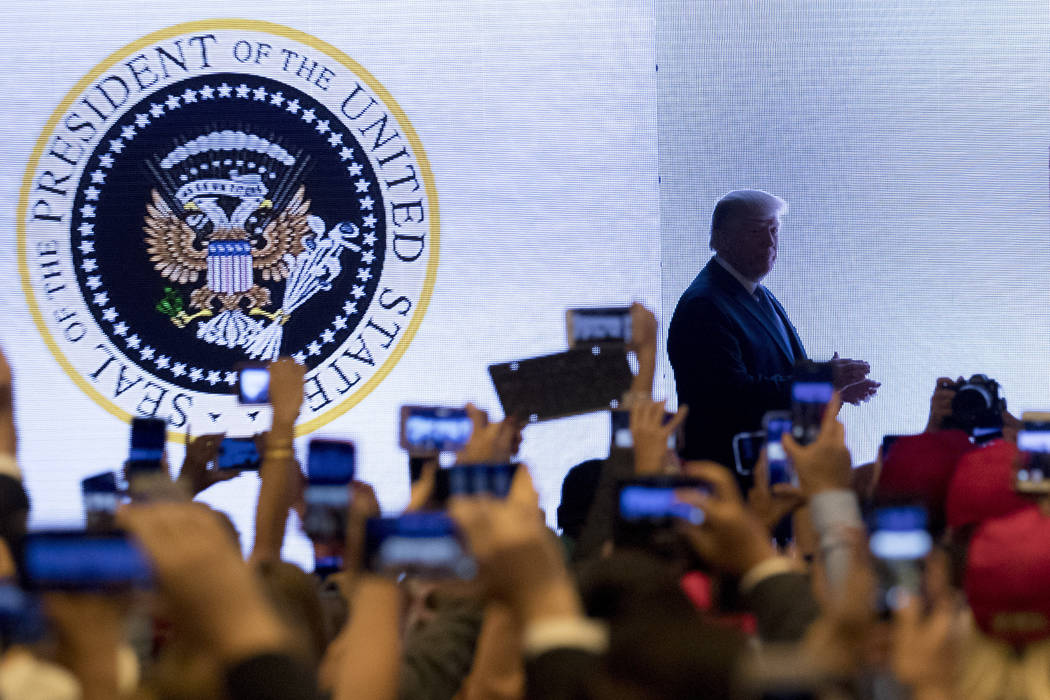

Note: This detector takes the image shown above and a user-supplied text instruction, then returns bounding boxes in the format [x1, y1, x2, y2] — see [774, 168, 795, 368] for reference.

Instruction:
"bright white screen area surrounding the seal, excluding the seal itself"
[0, 0, 659, 560]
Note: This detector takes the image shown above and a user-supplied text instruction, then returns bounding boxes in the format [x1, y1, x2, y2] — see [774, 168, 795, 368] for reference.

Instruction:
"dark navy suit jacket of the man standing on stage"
[667, 258, 805, 469]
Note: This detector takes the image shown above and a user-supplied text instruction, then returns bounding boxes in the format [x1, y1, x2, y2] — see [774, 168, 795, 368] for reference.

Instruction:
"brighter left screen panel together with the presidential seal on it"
[0, 0, 660, 563]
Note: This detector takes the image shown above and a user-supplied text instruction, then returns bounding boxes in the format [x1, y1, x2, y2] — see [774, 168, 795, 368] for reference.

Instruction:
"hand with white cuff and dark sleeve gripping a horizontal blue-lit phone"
[675, 462, 776, 576]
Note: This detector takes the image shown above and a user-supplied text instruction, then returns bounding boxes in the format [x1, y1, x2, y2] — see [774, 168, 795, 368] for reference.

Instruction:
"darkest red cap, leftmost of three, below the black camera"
[876, 430, 973, 512]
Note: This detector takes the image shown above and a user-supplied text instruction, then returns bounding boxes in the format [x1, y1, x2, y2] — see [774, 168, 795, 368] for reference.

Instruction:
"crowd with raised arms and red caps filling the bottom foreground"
[0, 304, 1050, 700]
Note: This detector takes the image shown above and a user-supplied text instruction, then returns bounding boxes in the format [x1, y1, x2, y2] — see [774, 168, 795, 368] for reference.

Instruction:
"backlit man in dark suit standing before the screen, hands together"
[667, 190, 879, 467]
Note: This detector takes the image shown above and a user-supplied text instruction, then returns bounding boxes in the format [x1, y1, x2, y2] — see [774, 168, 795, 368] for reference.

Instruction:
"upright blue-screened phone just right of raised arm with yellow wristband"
[302, 439, 355, 542]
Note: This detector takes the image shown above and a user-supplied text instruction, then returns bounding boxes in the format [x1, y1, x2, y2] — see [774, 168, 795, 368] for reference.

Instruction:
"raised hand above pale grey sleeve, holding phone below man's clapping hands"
[782, 393, 852, 499]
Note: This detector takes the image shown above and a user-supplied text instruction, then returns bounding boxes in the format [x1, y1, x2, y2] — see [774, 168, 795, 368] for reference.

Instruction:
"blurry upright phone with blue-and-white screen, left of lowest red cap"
[869, 505, 933, 615]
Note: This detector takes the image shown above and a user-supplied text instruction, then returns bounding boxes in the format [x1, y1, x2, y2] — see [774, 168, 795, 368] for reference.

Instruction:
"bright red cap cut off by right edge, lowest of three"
[964, 505, 1050, 644]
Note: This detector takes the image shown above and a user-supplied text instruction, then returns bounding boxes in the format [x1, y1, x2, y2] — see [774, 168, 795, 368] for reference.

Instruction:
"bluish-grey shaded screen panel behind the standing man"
[656, 0, 1050, 463]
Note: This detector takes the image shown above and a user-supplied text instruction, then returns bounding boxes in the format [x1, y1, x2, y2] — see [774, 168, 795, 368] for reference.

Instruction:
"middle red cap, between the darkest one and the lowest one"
[947, 440, 1032, 528]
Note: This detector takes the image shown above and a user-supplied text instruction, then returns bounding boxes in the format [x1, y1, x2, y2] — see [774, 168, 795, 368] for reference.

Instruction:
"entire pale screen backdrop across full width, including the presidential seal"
[0, 0, 1050, 565]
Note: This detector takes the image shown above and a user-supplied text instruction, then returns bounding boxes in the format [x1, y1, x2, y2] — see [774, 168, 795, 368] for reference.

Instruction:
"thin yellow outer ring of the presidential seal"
[16, 18, 441, 442]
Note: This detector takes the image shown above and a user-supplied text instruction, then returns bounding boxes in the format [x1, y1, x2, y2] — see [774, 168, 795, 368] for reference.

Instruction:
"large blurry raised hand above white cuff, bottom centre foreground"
[448, 496, 583, 623]
